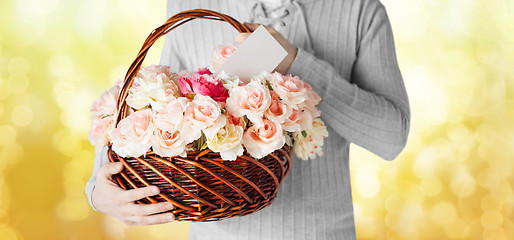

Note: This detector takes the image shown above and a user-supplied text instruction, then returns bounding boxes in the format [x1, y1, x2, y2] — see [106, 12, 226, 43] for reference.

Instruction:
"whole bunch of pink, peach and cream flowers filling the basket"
[89, 45, 328, 160]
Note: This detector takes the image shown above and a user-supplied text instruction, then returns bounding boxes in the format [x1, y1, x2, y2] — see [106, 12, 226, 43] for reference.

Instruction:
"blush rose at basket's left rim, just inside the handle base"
[109, 109, 154, 157]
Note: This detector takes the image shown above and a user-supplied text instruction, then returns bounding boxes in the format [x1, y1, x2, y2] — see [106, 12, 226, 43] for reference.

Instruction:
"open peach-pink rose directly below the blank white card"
[226, 81, 271, 124]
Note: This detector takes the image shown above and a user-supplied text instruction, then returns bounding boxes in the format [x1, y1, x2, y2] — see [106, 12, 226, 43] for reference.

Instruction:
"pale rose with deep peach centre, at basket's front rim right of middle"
[243, 119, 286, 158]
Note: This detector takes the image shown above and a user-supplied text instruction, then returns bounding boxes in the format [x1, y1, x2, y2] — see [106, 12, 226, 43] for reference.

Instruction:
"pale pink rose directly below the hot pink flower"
[180, 94, 227, 143]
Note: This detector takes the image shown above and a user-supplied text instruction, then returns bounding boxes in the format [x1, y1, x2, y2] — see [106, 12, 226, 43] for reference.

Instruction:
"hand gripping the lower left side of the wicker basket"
[91, 162, 175, 226]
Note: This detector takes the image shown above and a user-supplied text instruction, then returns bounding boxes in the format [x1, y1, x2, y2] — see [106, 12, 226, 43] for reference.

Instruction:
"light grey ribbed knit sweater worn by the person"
[86, 0, 410, 240]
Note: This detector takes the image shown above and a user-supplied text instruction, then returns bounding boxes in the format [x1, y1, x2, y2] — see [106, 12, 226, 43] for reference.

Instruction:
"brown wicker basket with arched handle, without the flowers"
[108, 9, 291, 222]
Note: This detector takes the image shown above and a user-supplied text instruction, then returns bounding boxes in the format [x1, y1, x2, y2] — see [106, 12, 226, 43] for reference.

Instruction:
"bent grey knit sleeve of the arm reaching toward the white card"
[288, 5, 410, 160]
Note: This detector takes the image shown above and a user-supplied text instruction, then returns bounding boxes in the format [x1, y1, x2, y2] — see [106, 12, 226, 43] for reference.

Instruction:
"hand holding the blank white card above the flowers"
[234, 23, 298, 74]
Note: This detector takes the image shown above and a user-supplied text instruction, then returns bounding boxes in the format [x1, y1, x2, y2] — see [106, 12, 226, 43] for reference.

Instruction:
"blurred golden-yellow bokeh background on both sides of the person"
[0, 0, 514, 240]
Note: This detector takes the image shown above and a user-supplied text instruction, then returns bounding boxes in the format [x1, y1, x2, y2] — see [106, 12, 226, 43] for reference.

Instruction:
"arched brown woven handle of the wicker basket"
[116, 9, 251, 125]
